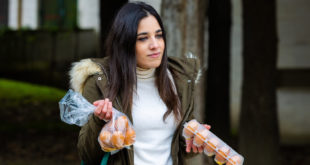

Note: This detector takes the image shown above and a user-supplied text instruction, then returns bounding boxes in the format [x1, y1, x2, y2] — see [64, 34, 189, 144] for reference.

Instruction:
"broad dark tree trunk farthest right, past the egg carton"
[239, 0, 279, 165]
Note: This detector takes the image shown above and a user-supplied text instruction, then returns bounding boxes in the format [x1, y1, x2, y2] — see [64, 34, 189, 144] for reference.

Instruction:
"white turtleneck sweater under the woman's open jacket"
[132, 68, 176, 165]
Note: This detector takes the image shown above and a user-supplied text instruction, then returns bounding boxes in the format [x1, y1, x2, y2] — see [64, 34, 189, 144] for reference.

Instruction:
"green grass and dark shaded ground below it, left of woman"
[0, 78, 80, 165]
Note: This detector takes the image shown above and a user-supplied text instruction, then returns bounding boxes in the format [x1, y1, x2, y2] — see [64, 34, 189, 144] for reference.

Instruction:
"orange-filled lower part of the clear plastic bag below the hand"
[98, 109, 136, 154]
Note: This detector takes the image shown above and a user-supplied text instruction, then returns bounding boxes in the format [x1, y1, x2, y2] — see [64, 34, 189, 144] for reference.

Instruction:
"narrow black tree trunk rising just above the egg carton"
[205, 0, 231, 144]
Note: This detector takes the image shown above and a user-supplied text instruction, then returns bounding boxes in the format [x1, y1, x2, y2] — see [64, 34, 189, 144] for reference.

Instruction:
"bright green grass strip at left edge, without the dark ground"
[0, 78, 66, 102]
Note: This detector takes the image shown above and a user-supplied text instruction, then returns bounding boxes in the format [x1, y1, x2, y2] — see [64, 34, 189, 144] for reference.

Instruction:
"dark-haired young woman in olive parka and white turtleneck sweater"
[70, 2, 209, 165]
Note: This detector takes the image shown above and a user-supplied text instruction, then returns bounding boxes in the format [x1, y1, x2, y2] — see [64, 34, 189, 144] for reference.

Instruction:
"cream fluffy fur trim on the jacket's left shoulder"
[69, 59, 107, 93]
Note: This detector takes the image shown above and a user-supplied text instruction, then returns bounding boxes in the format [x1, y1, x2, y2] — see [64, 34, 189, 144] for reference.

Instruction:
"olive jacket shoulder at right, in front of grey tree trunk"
[168, 54, 202, 83]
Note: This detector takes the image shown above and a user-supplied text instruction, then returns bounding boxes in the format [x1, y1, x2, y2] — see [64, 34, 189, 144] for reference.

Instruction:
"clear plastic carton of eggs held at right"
[183, 119, 244, 165]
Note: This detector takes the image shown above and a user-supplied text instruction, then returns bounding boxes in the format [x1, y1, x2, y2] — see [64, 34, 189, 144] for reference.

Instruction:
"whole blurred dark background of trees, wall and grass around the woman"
[0, 0, 310, 165]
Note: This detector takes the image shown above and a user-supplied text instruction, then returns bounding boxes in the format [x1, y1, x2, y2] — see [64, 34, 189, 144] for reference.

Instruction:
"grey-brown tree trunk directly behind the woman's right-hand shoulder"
[161, 0, 207, 165]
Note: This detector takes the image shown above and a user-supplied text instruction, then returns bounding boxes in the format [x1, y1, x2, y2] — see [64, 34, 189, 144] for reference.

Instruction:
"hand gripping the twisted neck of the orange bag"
[93, 98, 112, 121]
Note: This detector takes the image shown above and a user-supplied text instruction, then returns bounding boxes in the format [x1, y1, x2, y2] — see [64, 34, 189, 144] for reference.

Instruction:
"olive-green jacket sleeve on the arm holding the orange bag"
[77, 76, 105, 164]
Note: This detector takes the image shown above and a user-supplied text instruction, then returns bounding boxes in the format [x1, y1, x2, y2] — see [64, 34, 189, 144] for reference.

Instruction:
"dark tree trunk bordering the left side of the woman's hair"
[99, 0, 128, 56]
